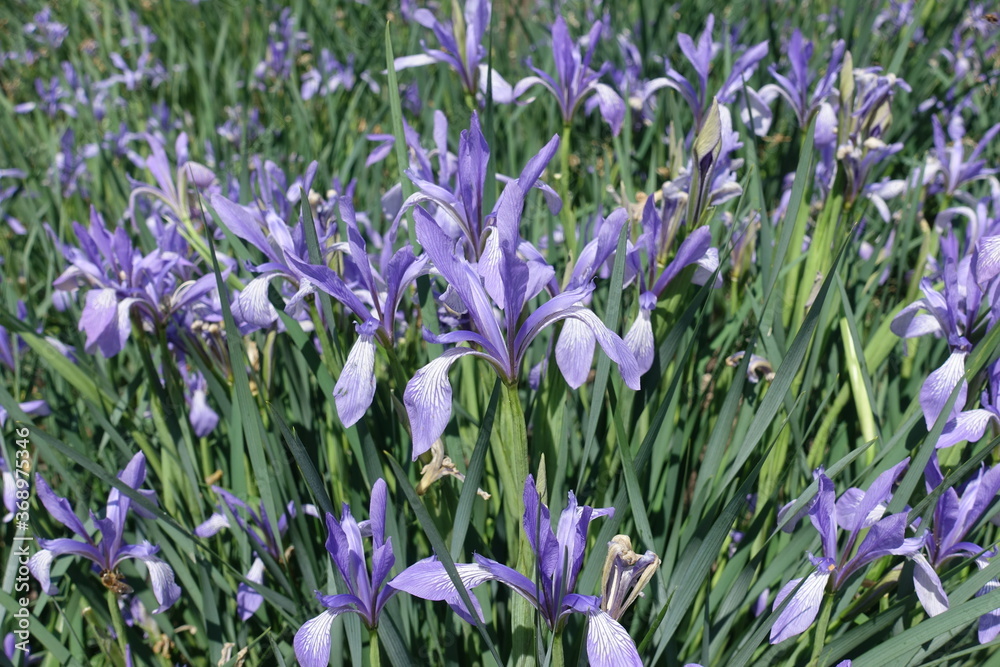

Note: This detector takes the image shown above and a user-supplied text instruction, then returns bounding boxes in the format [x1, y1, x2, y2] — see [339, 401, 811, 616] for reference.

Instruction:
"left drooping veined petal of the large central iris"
[403, 347, 484, 460]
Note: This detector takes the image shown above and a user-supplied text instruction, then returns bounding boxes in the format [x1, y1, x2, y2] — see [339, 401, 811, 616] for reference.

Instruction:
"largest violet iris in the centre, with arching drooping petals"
[403, 181, 639, 459]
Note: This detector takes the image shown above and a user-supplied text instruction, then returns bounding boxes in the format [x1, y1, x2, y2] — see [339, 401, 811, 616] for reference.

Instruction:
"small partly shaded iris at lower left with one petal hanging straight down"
[194, 486, 319, 621]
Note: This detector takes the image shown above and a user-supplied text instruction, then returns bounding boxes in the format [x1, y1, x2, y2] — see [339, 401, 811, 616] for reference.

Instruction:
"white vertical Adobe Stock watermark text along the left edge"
[5, 426, 35, 653]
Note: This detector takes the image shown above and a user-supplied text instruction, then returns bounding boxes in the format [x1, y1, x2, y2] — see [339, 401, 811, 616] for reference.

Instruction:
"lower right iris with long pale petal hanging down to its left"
[771, 457, 924, 644]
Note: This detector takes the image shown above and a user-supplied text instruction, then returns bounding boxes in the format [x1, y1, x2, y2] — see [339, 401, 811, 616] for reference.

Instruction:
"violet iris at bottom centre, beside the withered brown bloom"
[389, 475, 642, 667]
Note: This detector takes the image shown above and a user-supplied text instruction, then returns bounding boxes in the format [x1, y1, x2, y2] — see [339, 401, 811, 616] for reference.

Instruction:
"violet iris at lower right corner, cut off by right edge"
[913, 456, 1000, 644]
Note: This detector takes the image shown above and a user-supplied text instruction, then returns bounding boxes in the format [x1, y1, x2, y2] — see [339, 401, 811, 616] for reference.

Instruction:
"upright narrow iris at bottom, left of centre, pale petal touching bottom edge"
[294, 479, 396, 667]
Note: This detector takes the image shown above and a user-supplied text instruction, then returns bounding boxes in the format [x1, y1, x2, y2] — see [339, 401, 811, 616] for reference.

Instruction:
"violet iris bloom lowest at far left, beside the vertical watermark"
[28, 452, 181, 614]
